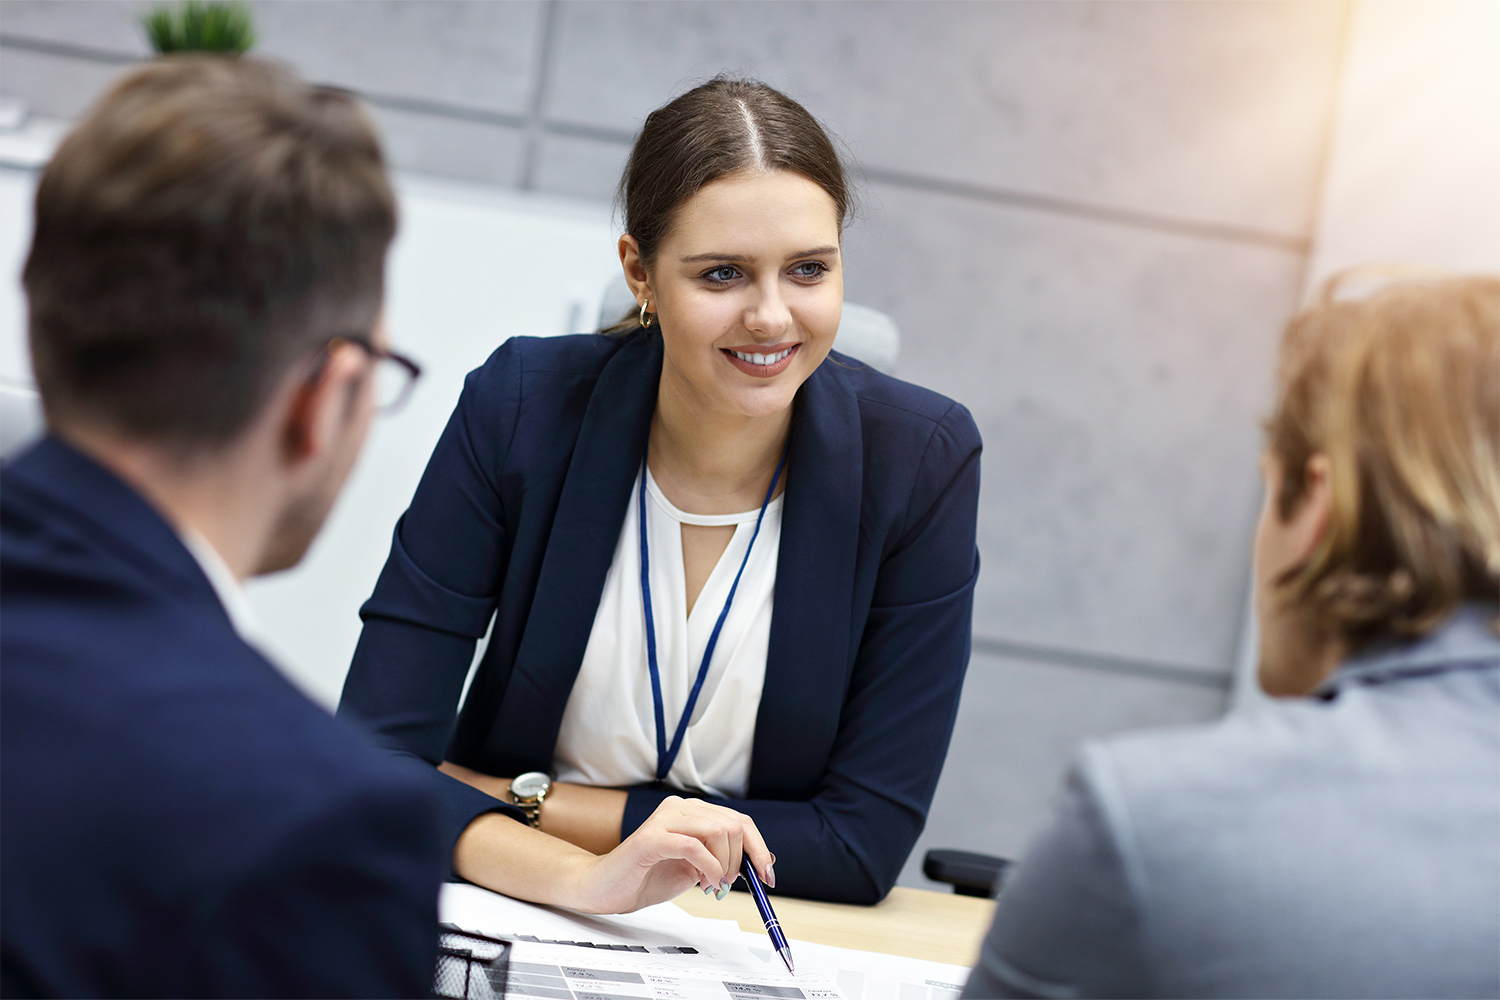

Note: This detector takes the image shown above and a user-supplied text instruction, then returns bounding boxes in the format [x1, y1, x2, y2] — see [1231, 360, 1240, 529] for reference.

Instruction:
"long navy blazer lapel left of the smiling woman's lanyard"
[480, 337, 662, 774]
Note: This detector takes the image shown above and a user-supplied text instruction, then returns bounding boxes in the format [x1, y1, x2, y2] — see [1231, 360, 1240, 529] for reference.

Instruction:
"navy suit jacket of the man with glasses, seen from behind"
[0, 438, 447, 997]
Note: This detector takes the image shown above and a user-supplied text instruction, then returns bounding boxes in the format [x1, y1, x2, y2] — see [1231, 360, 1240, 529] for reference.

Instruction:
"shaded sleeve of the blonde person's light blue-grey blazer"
[963, 747, 1160, 997]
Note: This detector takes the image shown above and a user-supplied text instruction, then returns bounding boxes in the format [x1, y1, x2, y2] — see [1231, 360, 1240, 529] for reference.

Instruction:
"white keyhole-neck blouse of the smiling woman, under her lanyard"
[554, 471, 785, 799]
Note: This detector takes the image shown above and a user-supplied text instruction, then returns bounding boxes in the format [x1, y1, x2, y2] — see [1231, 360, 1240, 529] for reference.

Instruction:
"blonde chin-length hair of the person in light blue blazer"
[1266, 276, 1500, 649]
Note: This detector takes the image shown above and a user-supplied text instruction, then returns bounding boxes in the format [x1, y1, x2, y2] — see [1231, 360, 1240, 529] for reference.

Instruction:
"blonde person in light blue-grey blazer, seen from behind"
[965, 277, 1500, 997]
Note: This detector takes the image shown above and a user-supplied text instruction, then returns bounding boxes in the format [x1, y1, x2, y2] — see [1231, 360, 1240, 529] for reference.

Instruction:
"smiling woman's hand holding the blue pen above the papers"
[569, 796, 776, 913]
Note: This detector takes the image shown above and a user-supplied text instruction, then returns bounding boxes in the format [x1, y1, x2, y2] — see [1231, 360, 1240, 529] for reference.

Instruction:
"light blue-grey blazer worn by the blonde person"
[965, 604, 1500, 997]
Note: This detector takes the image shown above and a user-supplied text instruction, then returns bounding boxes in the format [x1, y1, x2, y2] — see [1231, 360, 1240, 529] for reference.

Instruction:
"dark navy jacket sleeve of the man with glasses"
[183, 789, 447, 997]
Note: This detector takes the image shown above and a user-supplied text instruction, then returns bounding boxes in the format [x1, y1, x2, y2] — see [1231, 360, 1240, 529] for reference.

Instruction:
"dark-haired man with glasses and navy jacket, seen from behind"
[0, 57, 449, 997]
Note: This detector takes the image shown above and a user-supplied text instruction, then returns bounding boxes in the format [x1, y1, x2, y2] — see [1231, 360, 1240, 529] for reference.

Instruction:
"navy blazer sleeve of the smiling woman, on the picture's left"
[338, 342, 525, 846]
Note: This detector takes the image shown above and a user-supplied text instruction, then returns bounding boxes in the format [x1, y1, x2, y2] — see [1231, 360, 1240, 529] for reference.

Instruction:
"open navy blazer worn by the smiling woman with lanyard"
[339, 333, 980, 903]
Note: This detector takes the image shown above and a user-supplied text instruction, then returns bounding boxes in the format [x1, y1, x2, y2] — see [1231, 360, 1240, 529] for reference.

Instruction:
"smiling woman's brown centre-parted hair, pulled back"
[612, 76, 854, 330]
